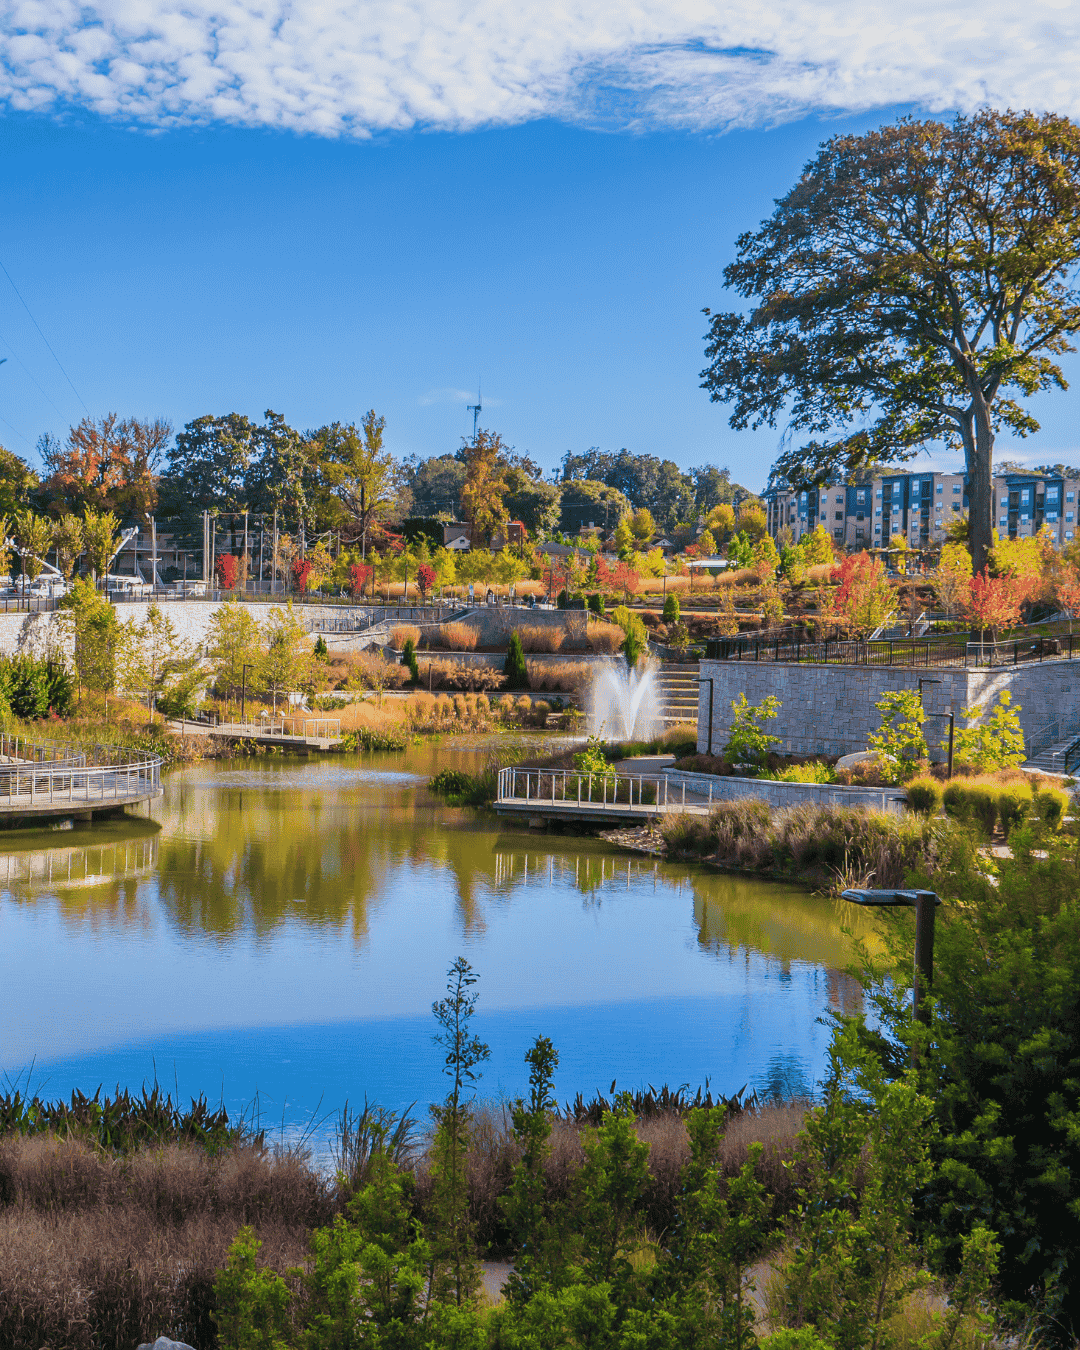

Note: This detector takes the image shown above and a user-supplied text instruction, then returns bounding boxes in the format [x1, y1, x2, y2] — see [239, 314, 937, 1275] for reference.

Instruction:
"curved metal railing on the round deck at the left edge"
[0, 734, 162, 811]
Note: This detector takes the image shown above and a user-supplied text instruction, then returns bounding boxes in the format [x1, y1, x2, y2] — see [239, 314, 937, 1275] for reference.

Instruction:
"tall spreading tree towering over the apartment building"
[702, 109, 1080, 572]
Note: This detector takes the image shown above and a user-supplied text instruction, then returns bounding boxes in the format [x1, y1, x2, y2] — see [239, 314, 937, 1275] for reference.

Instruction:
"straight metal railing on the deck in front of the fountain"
[495, 767, 713, 815]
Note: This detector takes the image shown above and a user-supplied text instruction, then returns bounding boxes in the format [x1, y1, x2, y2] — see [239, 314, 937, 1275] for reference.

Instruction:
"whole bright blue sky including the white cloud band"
[0, 0, 1080, 486]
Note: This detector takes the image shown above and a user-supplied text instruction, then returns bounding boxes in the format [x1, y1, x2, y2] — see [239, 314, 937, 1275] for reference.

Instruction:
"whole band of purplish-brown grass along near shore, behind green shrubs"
[0, 1091, 805, 1350]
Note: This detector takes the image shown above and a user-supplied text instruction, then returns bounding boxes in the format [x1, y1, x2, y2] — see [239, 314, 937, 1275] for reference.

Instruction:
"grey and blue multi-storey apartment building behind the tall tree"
[763, 473, 1080, 549]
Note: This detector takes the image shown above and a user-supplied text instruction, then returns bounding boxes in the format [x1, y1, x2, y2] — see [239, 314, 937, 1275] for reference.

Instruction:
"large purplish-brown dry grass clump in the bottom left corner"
[0, 1135, 325, 1350]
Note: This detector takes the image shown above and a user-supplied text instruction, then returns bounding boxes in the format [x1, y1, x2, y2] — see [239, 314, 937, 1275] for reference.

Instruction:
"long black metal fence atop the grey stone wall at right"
[705, 633, 1080, 670]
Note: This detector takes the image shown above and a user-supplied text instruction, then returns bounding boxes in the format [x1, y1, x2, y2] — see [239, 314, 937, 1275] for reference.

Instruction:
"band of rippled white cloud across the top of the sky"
[0, 0, 1080, 135]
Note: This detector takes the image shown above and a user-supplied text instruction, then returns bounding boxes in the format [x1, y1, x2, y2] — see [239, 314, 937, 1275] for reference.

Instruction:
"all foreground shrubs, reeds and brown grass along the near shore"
[0, 869, 1080, 1350]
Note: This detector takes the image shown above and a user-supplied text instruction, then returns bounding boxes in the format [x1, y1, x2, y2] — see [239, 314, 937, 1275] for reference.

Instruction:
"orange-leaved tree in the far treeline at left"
[38, 413, 173, 520]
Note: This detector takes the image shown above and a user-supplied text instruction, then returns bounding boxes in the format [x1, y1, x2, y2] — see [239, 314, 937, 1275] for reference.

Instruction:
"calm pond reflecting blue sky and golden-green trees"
[0, 741, 869, 1137]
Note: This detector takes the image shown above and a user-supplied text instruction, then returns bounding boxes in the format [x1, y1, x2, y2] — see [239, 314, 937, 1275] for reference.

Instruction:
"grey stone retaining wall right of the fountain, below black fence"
[698, 660, 1080, 759]
